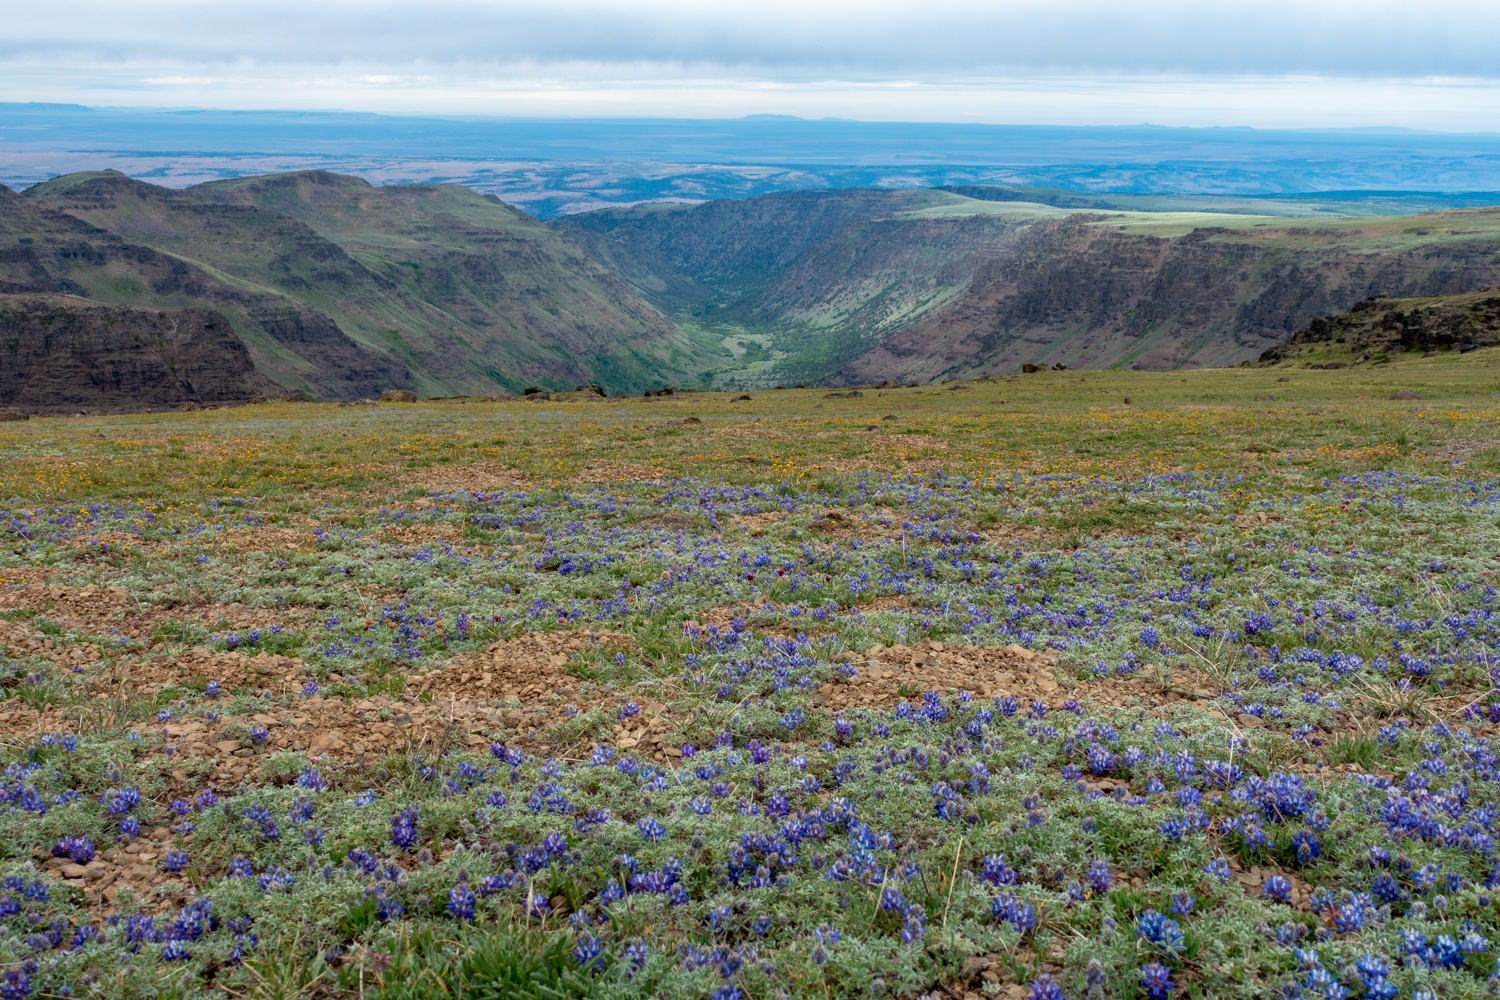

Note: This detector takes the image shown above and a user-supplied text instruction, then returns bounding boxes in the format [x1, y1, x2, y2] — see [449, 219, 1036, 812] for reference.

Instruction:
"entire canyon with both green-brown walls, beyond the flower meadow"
[0, 171, 1500, 409]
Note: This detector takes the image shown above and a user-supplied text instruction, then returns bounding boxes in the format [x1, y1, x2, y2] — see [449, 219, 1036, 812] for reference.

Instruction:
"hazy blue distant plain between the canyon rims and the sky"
[0, 103, 1500, 217]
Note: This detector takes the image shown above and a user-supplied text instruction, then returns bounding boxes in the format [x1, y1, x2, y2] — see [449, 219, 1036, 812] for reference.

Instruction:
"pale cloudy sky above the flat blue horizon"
[0, 0, 1500, 132]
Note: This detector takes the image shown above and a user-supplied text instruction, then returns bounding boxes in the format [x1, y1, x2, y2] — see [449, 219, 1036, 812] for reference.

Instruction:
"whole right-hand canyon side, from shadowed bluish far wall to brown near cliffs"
[555, 187, 1500, 384]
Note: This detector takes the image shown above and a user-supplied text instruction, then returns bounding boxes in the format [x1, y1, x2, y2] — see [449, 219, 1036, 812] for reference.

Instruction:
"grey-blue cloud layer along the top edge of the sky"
[11, 0, 1500, 81]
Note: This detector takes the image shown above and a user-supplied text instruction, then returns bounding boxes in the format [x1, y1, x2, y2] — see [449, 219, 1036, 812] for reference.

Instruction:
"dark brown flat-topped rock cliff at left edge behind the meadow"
[0, 295, 275, 414]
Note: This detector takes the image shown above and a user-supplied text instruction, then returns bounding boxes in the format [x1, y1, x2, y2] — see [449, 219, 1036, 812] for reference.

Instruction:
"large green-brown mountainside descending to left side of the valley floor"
[192, 172, 717, 391]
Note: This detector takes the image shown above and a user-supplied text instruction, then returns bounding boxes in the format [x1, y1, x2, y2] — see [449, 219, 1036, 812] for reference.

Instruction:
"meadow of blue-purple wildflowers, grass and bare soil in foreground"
[0, 359, 1500, 1000]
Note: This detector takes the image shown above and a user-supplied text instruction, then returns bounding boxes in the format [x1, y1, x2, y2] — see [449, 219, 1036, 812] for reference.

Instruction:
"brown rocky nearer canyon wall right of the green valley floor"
[837, 210, 1500, 382]
